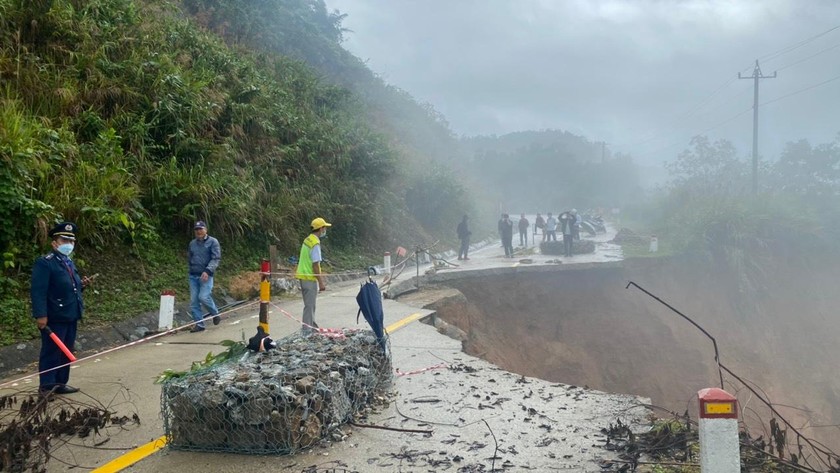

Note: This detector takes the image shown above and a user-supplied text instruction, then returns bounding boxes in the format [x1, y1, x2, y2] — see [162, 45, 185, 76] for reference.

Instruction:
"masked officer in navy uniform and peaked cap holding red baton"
[30, 222, 90, 394]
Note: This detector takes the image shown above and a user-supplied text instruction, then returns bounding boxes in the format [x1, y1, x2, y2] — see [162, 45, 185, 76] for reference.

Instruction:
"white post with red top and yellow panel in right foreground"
[697, 388, 741, 473]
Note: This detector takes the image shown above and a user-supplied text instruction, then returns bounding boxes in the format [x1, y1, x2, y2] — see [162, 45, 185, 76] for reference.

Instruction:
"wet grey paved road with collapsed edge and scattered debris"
[0, 227, 638, 472]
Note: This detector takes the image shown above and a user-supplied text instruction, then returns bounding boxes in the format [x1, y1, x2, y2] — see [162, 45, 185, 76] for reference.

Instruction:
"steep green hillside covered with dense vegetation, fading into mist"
[0, 0, 470, 343]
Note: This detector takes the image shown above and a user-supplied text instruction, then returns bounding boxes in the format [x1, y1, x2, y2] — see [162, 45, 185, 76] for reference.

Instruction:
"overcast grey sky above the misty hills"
[326, 0, 840, 163]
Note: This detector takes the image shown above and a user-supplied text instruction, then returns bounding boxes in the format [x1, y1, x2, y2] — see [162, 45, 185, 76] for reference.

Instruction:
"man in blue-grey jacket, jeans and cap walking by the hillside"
[187, 220, 222, 333]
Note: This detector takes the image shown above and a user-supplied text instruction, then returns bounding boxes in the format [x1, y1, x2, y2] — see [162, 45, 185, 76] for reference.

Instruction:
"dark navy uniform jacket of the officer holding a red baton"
[29, 251, 84, 322]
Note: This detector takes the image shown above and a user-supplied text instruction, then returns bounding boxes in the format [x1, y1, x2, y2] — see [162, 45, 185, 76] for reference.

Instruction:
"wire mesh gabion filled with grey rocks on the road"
[161, 330, 392, 454]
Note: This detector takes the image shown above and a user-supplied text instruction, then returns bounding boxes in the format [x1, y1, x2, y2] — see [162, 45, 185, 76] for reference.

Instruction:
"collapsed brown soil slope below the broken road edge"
[429, 259, 840, 449]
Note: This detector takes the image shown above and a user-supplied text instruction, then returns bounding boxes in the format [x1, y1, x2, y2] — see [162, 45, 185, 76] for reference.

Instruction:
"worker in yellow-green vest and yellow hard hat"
[295, 217, 332, 335]
